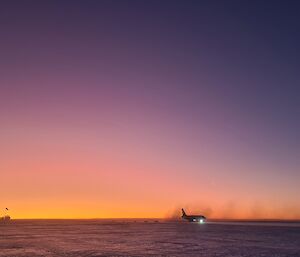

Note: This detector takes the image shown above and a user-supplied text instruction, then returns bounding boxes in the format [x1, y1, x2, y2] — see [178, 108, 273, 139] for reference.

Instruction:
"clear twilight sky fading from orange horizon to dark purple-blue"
[0, 0, 300, 219]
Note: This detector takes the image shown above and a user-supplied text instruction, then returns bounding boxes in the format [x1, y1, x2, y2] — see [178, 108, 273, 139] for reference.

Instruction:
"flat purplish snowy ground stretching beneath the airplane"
[0, 220, 300, 257]
